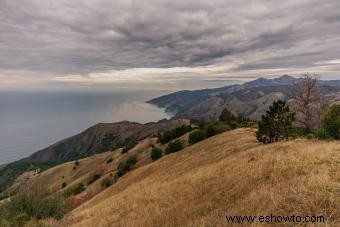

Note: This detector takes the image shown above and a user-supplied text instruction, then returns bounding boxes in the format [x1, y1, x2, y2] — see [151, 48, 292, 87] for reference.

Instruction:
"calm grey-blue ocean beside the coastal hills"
[0, 91, 171, 165]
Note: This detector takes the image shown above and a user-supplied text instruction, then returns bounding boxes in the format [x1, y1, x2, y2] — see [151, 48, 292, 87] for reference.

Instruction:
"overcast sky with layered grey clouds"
[0, 0, 340, 90]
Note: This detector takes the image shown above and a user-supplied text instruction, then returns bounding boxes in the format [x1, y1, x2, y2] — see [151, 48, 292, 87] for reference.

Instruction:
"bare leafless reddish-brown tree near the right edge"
[292, 73, 328, 133]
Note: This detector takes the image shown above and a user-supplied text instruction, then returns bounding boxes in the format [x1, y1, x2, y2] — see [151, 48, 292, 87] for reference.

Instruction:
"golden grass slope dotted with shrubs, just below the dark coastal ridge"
[27, 138, 157, 208]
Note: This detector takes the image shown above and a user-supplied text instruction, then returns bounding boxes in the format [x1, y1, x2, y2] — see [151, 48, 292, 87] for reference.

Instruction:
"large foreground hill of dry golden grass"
[59, 129, 340, 227]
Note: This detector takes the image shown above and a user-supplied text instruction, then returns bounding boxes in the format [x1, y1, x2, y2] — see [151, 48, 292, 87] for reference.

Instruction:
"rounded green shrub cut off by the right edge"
[321, 104, 340, 140]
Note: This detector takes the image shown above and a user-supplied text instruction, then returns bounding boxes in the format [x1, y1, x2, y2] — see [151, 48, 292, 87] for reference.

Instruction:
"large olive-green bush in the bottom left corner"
[0, 185, 69, 226]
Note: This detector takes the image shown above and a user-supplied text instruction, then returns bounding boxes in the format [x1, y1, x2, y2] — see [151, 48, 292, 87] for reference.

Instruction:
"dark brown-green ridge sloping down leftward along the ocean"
[0, 119, 190, 195]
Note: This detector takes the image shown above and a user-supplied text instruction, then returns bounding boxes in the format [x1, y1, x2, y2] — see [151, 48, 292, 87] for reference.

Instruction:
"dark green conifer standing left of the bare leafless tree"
[256, 100, 295, 143]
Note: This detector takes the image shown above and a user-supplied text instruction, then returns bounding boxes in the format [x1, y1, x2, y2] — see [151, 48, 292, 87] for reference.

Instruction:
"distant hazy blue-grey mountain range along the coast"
[148, 75, 340, 121]
